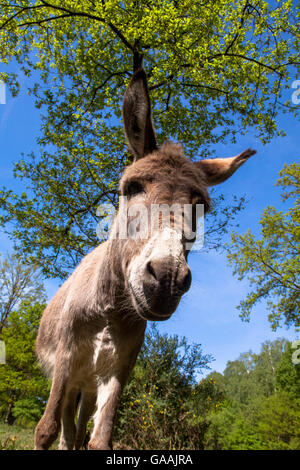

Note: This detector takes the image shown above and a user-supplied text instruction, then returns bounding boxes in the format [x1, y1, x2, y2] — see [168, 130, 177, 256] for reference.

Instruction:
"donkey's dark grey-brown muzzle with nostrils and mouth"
[143, 257, 192, 320]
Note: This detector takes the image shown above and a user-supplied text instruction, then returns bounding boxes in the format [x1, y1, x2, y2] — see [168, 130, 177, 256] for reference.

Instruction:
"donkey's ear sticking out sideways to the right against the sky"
[195, 149, 256, 186]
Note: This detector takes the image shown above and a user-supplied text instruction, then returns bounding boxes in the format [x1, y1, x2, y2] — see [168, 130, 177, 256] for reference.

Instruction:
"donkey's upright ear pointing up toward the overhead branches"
[123, 68, 157, 160]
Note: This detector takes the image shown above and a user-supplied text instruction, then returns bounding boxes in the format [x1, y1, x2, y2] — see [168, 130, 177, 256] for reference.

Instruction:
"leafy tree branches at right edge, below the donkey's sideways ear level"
[228, 163, 300, 330]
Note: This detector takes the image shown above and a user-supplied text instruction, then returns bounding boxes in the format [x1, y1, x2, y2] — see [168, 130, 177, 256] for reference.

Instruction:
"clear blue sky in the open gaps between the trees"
[0, 69, 300, 378]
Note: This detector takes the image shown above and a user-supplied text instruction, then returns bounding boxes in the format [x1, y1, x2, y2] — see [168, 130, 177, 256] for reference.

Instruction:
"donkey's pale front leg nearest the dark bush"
[88, 376, 123, 450]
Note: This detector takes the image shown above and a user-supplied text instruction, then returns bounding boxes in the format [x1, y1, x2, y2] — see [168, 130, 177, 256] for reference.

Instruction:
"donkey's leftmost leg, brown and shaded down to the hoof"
[35, 351, 70, 450]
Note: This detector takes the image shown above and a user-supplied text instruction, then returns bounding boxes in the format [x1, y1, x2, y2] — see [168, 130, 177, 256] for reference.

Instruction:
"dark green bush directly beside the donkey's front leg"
[114, 325, 212, 449]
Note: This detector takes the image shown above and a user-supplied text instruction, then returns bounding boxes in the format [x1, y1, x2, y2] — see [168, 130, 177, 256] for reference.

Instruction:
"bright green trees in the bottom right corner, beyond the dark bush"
[205, 339, 300, 450]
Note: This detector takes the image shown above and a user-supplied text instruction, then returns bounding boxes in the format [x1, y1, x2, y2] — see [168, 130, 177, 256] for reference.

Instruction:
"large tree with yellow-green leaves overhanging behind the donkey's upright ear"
[0, 0, 299, 277]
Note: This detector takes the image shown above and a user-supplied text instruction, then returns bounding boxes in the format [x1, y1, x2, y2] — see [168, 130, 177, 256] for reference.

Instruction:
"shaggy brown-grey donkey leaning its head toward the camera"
[35, 67, 255, 450]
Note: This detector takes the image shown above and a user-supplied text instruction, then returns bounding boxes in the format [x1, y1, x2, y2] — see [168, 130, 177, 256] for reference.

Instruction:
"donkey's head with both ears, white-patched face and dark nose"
[115, 69, 255, 320]
